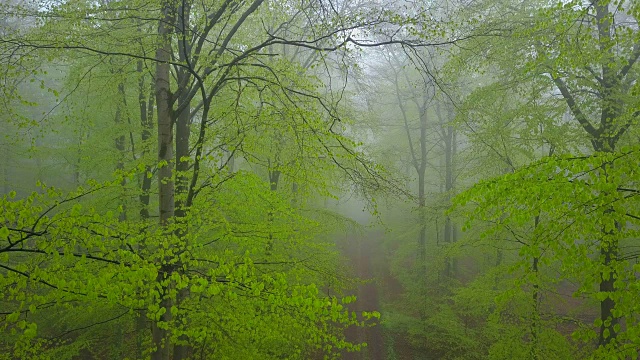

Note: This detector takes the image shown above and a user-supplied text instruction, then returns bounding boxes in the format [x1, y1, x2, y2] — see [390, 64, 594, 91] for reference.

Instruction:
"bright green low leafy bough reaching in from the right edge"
[454, 146, 640, 351]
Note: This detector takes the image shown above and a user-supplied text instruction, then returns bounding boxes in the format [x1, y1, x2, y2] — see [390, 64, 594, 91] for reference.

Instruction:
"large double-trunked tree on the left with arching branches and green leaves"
[0, 0, 450, 359]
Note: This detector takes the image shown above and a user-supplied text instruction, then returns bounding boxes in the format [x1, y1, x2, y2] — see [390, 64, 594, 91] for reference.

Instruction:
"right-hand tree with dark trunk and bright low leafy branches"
[450, 1, 639, 356]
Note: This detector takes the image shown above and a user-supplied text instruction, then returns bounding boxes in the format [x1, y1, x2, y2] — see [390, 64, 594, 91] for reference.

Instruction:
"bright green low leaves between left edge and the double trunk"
[0, 184, 148, 352]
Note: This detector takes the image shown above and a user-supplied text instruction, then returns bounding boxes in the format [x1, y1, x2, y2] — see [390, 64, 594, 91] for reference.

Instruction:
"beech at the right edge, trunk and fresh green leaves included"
[450, 1, 639, 357]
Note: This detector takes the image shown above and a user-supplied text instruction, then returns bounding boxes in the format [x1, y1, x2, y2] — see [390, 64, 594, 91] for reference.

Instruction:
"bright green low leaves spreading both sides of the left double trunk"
[0, 173, 368, 358]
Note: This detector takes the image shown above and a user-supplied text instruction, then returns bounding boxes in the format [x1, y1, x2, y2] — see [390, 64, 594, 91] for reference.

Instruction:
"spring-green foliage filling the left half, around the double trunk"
[0, 1, 404, 359]
